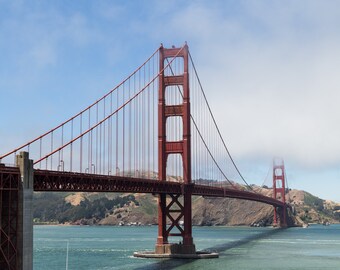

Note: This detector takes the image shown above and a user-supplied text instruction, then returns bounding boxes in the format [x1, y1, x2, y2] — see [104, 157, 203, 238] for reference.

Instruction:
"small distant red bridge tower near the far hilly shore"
[273, 159, 287, 227]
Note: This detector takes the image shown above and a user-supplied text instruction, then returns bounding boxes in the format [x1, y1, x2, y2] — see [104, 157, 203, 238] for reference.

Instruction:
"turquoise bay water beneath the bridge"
[34, 225, 340, 270]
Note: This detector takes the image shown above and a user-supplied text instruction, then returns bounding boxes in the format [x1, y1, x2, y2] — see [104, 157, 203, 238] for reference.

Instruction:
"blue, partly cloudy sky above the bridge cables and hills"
[0, 0, 340, 202]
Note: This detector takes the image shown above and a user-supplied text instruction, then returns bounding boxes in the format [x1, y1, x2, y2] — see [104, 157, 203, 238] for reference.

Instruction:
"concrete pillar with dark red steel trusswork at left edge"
[0, 152, 33, 270]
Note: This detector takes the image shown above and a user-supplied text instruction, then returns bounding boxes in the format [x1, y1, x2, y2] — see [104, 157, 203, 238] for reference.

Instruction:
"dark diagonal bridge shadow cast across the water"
[134, 228, 285, 270]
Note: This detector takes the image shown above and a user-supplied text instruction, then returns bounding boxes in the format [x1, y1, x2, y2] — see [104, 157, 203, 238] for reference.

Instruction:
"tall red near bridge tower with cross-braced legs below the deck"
[155, 44, 196, 254]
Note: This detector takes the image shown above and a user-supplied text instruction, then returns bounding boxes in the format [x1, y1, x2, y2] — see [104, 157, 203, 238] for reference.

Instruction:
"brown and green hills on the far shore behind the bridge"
[33, 186, 340, 226]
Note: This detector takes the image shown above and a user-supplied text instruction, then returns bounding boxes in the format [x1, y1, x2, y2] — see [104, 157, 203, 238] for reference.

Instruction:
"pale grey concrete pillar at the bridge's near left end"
[16, 152, 34, 270]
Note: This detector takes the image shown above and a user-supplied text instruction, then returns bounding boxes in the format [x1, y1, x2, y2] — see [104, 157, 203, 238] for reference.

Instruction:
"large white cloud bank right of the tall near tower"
[159, 1, 340, 171]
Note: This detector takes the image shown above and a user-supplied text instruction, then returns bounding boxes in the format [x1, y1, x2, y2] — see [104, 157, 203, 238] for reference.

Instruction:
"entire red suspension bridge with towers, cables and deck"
[0, 44, 287, 269]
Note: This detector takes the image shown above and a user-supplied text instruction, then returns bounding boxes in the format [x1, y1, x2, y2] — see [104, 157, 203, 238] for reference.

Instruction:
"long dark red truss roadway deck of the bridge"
[0, 167, 284, 207]
